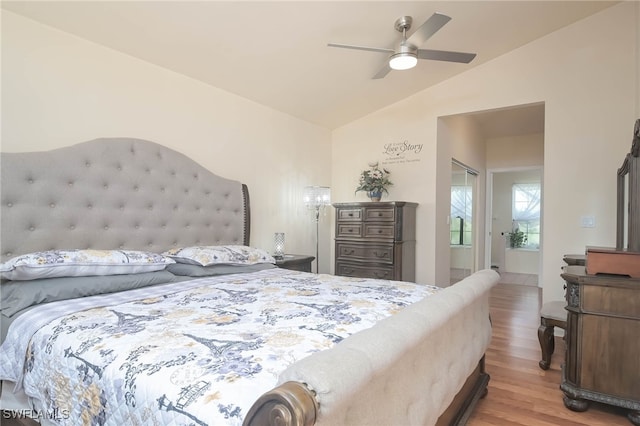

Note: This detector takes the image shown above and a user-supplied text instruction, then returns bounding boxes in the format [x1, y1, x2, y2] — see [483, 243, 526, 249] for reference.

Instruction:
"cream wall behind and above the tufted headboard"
[1, 11, 331, 272]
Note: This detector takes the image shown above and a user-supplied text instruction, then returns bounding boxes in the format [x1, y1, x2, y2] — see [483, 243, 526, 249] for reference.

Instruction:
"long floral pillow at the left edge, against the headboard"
[0, 250, 175, 281]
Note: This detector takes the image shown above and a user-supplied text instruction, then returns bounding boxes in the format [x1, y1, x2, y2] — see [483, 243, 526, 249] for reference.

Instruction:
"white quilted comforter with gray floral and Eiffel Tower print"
[0, 269, 439, 426]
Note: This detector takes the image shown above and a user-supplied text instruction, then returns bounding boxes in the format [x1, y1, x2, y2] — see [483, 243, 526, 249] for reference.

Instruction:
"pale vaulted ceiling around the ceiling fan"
[2, 0, 615, 129]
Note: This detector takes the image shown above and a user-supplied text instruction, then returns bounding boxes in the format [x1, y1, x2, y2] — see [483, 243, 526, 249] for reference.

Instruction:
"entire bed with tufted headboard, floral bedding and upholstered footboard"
[0, 138, 498, 425]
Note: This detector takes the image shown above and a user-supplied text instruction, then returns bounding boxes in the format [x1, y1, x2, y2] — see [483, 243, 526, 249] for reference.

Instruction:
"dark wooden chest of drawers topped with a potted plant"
[333, 201, 418, 281]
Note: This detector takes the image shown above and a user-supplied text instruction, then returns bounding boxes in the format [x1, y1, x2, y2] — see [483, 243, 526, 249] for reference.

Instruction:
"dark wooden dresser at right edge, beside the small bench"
[560, 265, 640, 426]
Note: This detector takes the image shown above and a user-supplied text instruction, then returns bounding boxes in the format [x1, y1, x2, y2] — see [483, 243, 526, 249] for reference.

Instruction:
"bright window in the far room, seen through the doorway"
[512, 183, 540, 248]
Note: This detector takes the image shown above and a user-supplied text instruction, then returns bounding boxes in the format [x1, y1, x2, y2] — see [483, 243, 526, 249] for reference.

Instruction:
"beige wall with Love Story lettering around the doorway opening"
[332, 2, 640, 300]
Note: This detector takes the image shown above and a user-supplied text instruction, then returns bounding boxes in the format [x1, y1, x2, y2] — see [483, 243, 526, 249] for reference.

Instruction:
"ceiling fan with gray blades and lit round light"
[328, 13, 476, 79]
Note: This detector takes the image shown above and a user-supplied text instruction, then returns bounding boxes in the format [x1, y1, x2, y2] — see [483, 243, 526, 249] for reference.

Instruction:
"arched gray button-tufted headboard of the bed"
[0, 138, 250, 262]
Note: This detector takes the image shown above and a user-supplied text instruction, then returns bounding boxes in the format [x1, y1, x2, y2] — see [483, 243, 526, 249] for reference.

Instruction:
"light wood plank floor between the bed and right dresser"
[467, 283, 631, 426]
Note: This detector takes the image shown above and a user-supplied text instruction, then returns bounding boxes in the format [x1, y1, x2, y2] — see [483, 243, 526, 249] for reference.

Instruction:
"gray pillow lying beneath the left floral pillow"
[0, 270, 184, 317]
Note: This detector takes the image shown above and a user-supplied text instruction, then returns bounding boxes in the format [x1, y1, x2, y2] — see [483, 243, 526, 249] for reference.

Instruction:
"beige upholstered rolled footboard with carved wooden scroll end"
[245, 270, 499, 426]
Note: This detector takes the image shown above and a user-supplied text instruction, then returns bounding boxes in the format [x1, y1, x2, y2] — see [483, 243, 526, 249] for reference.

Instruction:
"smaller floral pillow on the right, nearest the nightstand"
[162, 245, 276, 266]
